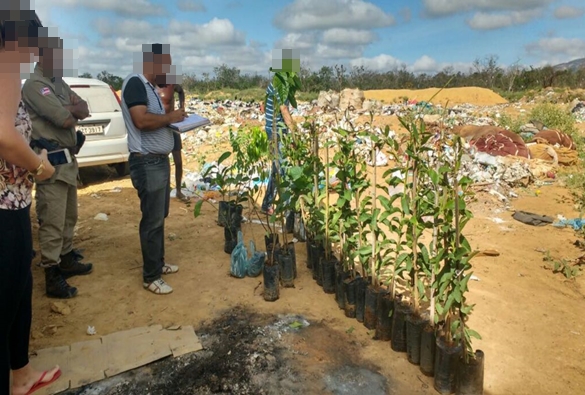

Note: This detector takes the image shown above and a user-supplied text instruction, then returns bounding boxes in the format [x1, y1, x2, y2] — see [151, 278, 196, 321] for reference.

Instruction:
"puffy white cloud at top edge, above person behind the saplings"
[273, 0, 394, 31]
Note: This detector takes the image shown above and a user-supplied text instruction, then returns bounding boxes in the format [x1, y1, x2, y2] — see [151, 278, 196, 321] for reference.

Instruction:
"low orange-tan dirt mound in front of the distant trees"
[364, 87, 507, 106]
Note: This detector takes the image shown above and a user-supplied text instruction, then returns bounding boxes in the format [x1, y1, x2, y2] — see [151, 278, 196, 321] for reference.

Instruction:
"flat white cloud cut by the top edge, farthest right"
[423, 0, 557, 17]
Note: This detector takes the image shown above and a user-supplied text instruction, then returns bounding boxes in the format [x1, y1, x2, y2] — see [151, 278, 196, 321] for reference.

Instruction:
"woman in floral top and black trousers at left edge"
[0, 10, 61, 395]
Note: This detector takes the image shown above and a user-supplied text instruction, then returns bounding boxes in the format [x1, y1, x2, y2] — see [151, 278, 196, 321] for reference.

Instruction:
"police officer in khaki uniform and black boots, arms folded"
[22, 40, 93, 299]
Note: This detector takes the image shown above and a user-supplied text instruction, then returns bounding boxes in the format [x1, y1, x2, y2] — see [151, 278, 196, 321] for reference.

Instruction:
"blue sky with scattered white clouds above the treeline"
[36, 0, 585, 76]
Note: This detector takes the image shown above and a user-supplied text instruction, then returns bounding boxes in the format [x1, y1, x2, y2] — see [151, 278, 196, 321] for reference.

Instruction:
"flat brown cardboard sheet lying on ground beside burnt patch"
[31, 325, 203, 395]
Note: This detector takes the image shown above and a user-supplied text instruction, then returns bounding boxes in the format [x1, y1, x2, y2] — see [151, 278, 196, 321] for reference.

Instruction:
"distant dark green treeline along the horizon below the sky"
[81, 56, 585, 93]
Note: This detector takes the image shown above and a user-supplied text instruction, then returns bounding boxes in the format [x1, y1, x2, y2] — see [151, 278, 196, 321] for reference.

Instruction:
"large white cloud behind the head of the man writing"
[71, 18, 271, 76]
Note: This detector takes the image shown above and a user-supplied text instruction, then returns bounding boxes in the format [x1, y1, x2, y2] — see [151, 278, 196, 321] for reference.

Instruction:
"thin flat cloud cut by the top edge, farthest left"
[51, 0, 167, 17]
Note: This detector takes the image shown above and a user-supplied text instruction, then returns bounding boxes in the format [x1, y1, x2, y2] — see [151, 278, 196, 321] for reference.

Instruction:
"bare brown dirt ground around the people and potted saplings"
[26, 89, 585, 395]
